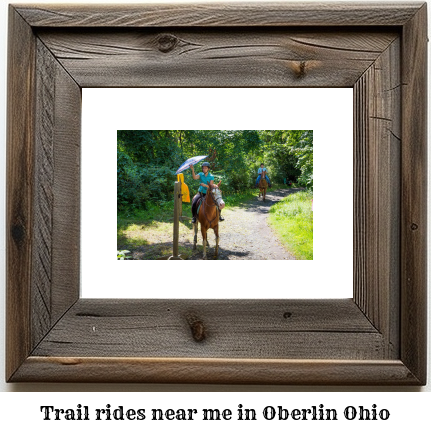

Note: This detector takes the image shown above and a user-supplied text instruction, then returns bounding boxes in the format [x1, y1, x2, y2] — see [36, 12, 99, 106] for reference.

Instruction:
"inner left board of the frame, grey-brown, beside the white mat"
[32, 40, 81, 346]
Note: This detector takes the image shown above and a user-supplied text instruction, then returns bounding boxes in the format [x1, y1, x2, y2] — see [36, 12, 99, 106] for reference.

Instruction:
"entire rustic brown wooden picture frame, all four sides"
[6, 2, 427, 385]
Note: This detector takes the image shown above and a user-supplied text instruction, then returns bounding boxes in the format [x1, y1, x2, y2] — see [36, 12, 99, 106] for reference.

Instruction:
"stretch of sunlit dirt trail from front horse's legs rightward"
[189, 189, 300, 260]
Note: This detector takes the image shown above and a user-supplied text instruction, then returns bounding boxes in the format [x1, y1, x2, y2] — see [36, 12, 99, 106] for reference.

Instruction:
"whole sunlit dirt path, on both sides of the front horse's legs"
[128, 189, 301, 260]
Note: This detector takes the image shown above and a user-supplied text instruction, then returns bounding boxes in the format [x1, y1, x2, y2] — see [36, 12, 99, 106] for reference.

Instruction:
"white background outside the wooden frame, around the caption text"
[0, 0, 431, 424]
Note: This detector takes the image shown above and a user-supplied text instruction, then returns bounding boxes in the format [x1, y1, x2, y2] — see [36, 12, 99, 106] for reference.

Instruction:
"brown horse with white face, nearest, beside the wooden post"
[193, 181, 225, 259]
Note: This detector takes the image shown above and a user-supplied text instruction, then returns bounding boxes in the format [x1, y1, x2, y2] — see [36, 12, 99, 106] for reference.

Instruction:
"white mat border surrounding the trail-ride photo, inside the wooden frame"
[81, 88, 353, 299]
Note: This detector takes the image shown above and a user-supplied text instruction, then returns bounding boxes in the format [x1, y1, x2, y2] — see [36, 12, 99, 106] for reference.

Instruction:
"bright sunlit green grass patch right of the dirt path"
[268, 192, 313, 260]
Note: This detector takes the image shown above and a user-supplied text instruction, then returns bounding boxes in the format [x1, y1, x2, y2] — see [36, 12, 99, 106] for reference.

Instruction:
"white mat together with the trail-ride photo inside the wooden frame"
[80, 88, 353, 299]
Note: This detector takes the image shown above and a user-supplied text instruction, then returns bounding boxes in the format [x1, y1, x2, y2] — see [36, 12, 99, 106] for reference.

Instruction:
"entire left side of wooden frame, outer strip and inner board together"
[7, 9, 81, 382]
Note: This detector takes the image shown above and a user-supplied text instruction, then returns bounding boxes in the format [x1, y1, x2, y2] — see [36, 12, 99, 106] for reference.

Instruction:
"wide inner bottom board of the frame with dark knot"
[33, 299, 385, 359]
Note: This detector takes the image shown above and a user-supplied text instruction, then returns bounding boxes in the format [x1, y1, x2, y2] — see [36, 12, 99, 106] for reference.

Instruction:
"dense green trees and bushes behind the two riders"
[117, 130, 313, 213]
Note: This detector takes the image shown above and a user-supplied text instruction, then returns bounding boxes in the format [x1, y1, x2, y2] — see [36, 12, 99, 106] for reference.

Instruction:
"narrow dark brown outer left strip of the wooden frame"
[6, 9, 36, 377]
